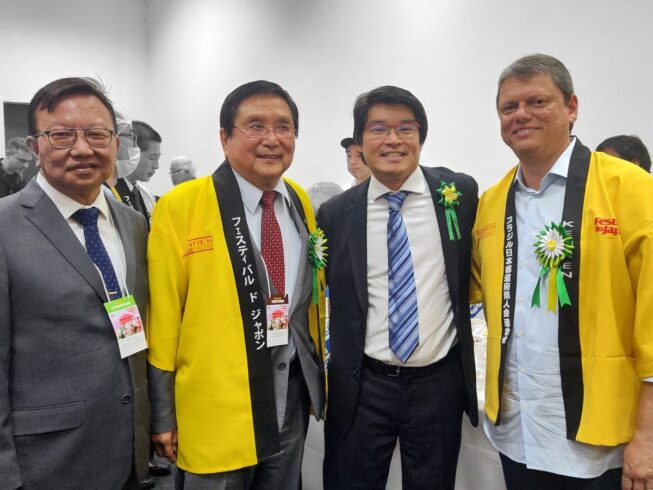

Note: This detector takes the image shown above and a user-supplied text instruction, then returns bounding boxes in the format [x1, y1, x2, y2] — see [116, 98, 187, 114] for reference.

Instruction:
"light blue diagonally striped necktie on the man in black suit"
[383, 191, 419, 362]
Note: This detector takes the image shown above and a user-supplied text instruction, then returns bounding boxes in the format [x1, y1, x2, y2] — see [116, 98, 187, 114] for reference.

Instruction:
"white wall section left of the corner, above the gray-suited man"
[0, 0, 148, 151]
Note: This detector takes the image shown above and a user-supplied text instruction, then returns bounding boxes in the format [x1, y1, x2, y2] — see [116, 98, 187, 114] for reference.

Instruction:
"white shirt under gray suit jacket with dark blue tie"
[36, 172, 130, 297]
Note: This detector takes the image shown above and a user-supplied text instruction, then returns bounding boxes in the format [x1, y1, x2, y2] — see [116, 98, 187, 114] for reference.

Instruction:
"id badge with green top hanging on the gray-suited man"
[104, 294, 147, 359]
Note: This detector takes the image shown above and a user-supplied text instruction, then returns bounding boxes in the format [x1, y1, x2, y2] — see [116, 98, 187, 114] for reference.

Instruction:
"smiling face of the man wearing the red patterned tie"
[220, 95, 295, 191]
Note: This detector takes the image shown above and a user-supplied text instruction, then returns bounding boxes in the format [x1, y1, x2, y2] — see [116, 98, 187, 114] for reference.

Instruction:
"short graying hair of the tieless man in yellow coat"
[496, 53, 574, 107]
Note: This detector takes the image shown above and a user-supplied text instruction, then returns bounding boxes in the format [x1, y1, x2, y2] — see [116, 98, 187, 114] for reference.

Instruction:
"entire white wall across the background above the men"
[0, 0, 653, 193]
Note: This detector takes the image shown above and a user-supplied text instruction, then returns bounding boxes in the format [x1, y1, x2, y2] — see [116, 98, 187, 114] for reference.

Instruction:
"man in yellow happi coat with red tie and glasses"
[148, 81, 325, 489]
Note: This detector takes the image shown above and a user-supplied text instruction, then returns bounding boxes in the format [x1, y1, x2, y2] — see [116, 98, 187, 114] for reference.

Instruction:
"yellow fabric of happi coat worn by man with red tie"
[148, 167, 324, 473]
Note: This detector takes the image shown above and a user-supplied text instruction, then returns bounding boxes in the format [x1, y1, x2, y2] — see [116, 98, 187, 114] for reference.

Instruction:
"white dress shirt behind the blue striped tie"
[365, 167, 456, 367]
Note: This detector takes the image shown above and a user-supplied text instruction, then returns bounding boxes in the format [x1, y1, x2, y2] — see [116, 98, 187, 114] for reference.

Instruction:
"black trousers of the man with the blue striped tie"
[324, 348, 465, 490]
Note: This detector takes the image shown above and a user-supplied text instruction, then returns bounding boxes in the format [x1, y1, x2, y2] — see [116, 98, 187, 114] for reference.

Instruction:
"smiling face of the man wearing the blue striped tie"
[362, 104, 422, 190]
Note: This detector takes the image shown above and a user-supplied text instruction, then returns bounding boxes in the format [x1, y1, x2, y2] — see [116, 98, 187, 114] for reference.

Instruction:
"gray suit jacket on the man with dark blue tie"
[0, 180, 149, 490]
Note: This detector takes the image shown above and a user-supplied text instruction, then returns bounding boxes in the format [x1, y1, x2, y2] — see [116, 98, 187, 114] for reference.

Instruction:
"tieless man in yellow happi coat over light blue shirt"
[471, 54, 653, 490]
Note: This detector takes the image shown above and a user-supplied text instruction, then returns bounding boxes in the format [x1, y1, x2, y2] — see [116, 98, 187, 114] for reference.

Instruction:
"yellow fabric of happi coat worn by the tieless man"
[471, 143, 653, 446]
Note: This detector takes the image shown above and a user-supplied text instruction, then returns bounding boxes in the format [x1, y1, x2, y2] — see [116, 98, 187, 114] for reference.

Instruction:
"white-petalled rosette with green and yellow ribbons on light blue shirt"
[531, 222, 574, 312]
